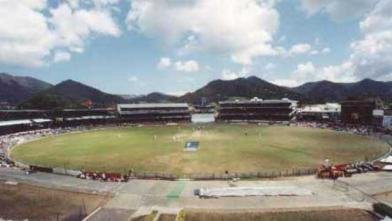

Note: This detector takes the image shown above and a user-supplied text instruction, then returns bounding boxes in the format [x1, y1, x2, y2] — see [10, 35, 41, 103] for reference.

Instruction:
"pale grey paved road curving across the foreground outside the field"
[0, 168, 392, 220]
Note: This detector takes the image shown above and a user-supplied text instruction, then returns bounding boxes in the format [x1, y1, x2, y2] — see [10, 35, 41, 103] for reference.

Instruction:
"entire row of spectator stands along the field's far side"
[0, 98, 392, 135]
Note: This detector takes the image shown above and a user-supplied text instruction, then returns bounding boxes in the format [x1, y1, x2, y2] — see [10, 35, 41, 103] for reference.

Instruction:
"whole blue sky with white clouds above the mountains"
[0, 0, 392, 95]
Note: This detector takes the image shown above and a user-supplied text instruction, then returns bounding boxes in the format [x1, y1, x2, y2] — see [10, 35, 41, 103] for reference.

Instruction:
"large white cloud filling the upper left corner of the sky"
[0, 0, 121, 67]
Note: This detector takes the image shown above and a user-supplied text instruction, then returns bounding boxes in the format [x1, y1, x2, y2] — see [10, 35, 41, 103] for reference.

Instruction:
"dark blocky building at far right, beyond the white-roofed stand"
[341, 99, 383, 125]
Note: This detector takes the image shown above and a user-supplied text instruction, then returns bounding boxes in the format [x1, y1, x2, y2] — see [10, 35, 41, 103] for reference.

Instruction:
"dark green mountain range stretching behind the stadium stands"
[0, 73, 392, 109]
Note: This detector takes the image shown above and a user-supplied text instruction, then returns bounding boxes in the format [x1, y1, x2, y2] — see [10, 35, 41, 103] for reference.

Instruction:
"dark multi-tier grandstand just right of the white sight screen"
[217, 98, 297, 122]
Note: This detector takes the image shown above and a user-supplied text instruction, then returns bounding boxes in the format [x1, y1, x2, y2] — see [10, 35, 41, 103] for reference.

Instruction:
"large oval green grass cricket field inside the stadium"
[11, 124, 389, 174]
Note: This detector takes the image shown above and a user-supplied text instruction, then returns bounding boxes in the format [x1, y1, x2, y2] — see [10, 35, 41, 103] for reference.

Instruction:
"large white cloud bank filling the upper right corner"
[294, 0, 392, 81]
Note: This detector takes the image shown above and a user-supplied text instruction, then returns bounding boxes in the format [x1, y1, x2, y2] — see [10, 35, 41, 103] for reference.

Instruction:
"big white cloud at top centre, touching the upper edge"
[127, 0, 279, 64]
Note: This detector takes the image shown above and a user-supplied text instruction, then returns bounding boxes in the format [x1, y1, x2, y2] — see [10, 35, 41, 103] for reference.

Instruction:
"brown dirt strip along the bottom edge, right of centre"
[184, 209, 377, 221]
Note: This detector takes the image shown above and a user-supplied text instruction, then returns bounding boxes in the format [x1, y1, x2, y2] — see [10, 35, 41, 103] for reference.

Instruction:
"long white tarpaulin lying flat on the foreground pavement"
[199, 186, 313, 197]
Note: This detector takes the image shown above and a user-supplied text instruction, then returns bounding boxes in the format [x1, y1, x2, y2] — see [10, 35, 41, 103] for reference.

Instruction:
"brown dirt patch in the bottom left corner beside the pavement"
[0, 183, 110, 220]
